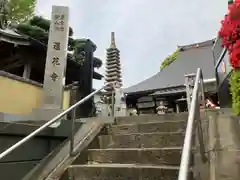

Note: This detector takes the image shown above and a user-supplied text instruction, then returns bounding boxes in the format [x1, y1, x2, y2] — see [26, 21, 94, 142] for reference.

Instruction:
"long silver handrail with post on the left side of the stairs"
[0, 83, 114, 160]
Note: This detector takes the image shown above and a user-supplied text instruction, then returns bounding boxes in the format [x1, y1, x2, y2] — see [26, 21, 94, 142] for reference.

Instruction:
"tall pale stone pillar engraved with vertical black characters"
[32, 6, 69, 125]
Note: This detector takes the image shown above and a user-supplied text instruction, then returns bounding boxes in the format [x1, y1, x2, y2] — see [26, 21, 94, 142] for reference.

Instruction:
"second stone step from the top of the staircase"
[108, 121, 186, 134]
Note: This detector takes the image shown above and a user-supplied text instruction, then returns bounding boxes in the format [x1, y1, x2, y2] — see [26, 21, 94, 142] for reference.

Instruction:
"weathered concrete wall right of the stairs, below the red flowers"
[194, 108, 240, 180]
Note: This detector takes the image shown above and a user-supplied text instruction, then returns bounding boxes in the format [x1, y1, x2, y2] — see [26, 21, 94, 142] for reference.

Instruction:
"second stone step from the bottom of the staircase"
[87, 147, 182, 166]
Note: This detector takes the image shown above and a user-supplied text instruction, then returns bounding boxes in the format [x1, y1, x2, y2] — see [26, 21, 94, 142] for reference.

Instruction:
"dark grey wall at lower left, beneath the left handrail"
[0, 121, 81, 180]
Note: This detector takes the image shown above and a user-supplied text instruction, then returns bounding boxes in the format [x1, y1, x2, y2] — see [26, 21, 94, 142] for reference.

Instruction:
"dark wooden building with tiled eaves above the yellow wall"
[0, 29, 102, 85]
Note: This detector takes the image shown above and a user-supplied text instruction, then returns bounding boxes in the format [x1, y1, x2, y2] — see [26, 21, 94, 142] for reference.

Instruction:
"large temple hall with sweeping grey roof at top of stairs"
[124, 39, 218, 114]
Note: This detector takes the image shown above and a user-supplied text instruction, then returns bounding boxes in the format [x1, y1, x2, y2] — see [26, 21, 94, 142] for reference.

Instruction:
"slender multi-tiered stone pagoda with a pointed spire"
[105, 32, 122, 97]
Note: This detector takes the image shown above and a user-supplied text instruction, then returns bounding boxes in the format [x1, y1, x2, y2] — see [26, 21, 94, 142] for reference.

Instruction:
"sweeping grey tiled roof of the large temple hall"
[124, 40, 215, 94]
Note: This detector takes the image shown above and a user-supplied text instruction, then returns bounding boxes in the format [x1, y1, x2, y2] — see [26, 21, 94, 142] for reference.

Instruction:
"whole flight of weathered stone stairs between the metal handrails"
[61, 116, 193, 180]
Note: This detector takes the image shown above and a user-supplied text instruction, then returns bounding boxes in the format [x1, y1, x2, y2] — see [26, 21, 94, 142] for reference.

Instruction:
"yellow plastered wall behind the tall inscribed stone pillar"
[0, 71, 70, 115]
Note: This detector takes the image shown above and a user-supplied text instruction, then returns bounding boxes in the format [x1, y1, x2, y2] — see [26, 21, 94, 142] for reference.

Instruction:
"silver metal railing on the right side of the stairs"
[178, 68, 207, 180]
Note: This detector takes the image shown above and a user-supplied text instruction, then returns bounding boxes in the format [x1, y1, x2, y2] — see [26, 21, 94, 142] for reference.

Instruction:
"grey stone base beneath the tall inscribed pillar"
[32, 108, 66, 128]
